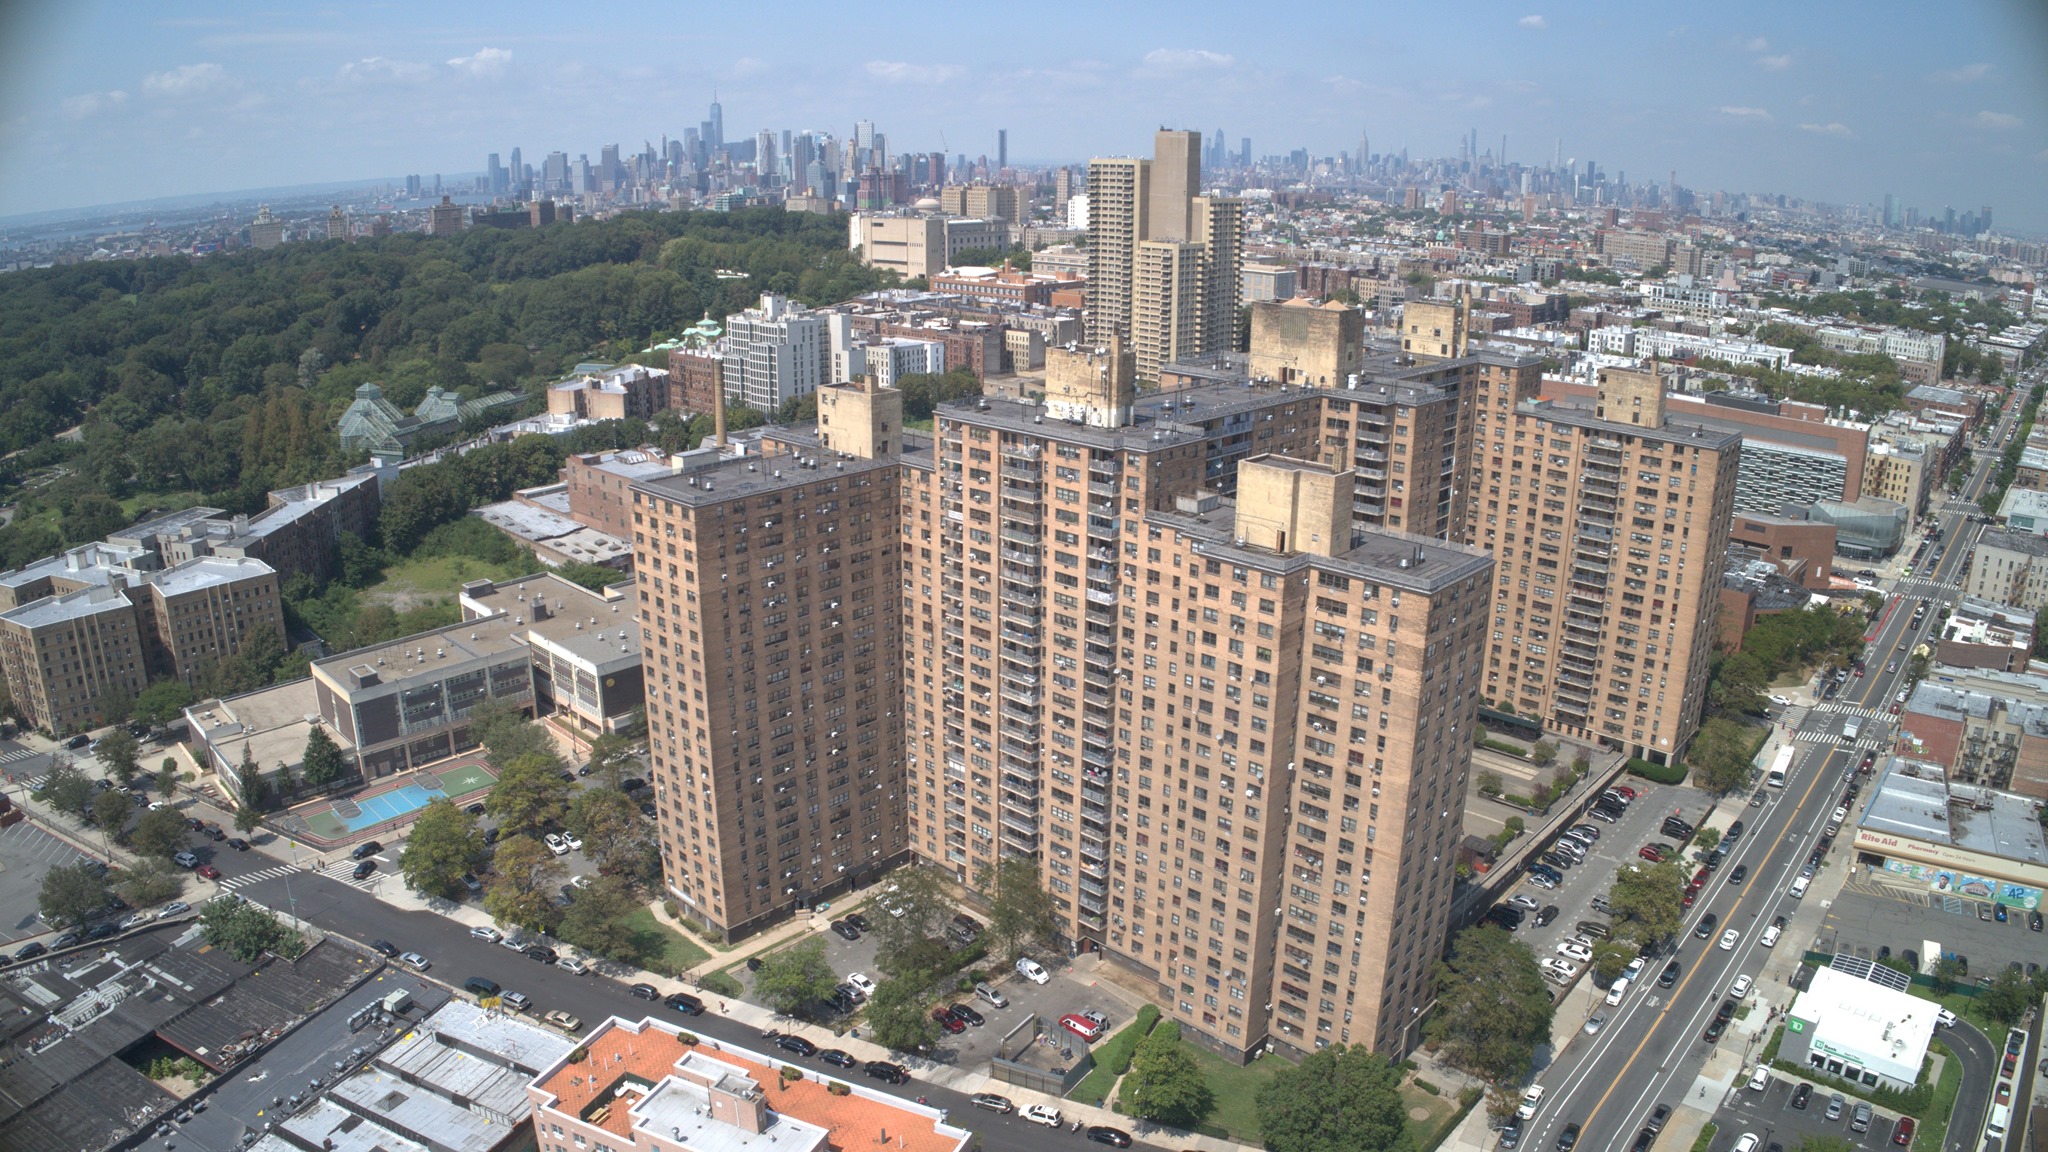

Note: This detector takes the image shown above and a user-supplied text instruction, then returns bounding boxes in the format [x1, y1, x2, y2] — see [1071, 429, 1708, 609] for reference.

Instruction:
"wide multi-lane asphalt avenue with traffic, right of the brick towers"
[1524, 407, 2005, 1148]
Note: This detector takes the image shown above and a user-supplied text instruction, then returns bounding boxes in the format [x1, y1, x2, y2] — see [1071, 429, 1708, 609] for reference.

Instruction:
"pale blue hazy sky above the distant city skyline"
[0, 0, 2048, 236]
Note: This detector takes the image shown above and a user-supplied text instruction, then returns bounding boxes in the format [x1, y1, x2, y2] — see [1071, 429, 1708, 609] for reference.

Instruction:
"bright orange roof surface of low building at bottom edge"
[539, 1021, 961, 1152]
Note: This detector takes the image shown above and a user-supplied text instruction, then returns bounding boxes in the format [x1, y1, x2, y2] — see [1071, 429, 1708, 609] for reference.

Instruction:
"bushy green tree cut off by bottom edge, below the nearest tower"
[1257, 1043, 1415, 1152]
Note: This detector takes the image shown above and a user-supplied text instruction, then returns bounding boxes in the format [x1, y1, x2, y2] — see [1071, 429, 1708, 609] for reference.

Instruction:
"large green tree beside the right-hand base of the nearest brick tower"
[1423, 924, 1556, 1084]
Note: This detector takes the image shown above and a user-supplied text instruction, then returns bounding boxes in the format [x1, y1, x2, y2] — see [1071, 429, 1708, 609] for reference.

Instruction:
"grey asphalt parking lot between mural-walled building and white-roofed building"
[1815, 867, 2048, 980]
